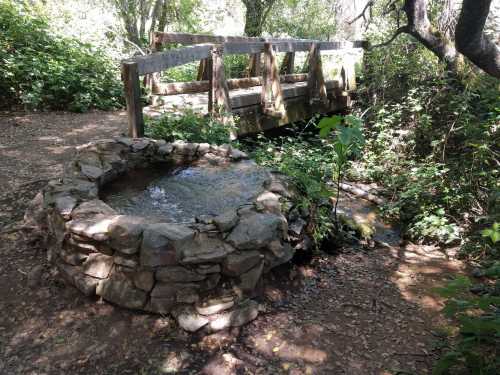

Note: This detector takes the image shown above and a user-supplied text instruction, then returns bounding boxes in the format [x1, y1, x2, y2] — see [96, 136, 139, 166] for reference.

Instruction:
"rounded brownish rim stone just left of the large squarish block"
[109, 215, 145, 255]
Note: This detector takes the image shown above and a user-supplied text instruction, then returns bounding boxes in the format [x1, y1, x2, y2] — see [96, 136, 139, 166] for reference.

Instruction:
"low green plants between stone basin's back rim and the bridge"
[145, 110, 233, 145]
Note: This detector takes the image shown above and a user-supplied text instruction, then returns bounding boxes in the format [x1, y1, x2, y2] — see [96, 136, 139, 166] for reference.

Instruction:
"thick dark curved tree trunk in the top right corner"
[455, 0, 500, 78]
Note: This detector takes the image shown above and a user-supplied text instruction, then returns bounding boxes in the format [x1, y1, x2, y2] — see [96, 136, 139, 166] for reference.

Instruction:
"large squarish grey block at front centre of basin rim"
[140, 223, 195, 267]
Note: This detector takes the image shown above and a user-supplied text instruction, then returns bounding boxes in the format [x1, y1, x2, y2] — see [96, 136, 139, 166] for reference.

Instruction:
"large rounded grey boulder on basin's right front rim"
[227, 213, 286, 250]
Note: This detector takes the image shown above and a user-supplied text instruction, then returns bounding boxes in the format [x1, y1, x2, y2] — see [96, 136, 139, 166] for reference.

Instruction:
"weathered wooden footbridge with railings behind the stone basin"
[122, 32, 366, 137]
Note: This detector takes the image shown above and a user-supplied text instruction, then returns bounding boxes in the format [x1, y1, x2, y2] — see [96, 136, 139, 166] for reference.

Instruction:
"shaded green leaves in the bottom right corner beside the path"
[433, 274, 500, 375]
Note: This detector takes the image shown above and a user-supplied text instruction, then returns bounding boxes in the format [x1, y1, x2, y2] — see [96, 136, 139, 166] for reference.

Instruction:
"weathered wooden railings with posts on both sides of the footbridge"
[122, 32, 366, 137]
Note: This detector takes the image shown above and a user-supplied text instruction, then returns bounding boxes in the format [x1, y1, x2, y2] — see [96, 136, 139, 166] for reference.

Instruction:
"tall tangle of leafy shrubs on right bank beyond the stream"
[353, 36, 500, 248]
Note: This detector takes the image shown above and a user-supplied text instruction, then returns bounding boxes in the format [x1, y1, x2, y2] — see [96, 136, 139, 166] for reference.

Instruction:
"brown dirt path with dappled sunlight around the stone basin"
[0, 112, 461, 375]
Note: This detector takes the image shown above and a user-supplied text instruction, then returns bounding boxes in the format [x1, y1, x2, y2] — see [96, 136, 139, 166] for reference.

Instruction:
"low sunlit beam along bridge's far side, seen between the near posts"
[152, 72, 307, 95]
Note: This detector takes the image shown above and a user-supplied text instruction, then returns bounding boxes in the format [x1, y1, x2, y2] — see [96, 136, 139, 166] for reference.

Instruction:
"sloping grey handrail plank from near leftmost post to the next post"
[125, 44, 212, 75]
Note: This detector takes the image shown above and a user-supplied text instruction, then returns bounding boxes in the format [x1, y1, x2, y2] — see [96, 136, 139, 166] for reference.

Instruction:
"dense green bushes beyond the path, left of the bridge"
[0, 0, 122, 112]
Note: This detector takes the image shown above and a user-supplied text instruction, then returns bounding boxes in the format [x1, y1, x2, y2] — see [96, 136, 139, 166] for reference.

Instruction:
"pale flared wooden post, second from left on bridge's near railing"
[208, 45, 231, 117]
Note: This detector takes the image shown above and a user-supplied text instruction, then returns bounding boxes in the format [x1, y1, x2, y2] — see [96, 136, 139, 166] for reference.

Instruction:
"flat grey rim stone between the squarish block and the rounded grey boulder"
[176, 233, 234, 264]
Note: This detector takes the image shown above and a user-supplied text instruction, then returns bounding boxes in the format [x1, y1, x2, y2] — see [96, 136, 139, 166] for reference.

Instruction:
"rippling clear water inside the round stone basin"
[101, 160, 269, 223]
